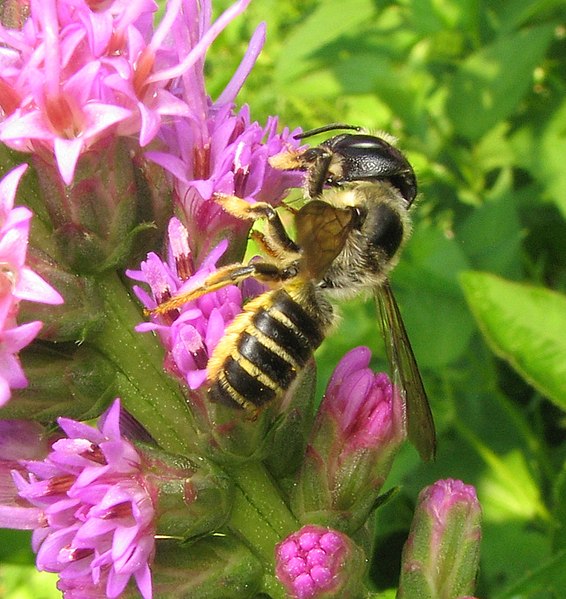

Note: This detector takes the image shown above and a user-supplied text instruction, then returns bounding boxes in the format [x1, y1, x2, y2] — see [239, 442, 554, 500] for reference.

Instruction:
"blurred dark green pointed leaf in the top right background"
[447, 25, 554, 140]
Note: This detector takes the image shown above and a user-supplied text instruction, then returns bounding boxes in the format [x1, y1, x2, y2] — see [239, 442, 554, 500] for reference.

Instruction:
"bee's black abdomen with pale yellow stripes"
[209, 289, 330, 411]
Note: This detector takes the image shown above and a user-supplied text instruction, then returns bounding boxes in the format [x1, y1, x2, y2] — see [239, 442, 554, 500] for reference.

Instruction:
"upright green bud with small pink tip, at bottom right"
[397, 479, 481, 599]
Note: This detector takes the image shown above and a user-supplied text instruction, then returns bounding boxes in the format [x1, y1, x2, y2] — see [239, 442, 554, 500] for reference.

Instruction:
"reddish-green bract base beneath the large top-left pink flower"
[33, 138, 170, 274]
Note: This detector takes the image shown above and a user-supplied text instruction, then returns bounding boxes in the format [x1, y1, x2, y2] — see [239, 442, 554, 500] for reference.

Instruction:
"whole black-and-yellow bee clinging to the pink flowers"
[152, 125, 436, 460]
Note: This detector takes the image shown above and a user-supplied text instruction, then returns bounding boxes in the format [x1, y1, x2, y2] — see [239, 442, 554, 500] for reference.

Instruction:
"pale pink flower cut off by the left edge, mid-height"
[0, 165, 63, 405]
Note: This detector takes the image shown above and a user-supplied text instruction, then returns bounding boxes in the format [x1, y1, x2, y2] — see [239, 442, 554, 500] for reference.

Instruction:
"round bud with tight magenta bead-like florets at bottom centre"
[275, 524, 366, 599]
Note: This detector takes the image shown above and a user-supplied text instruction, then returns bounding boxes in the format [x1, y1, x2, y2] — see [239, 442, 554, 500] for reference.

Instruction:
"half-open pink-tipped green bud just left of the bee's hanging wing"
[292, 347, 405, 531]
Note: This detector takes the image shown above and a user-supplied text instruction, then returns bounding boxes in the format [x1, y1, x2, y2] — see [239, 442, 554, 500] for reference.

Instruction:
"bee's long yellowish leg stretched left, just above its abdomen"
[147, 262, 297, 314]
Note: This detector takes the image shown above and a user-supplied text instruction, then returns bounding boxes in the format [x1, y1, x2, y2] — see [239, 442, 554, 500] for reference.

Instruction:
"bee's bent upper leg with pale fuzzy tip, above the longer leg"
[215, 194, 300, 254]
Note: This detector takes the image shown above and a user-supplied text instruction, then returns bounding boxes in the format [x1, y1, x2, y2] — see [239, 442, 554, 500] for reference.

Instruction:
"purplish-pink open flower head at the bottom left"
[13, 401, 156, 599]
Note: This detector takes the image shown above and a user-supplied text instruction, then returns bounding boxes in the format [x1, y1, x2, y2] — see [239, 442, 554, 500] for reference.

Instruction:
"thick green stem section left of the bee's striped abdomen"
[96, 273, 198, 454]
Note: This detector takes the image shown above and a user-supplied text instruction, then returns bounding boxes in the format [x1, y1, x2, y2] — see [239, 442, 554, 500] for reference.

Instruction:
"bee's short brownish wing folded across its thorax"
[295, 200, 354, 279]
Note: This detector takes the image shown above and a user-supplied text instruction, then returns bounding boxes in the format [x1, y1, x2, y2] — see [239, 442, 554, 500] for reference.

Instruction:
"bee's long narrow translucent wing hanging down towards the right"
[375, 281, 436, 461]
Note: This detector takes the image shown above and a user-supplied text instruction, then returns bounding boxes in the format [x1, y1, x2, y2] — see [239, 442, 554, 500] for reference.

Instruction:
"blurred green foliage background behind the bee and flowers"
[0, 0, 566, 599]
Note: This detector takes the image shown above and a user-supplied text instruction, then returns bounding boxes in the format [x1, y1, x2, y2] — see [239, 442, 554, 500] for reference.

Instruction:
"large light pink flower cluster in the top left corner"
[0, 0, 258, 185]
